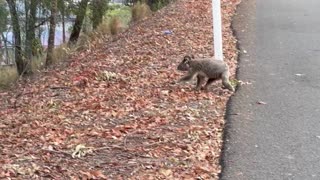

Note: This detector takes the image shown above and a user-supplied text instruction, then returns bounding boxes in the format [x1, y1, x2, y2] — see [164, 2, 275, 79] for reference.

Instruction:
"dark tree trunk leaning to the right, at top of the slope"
[68, 0, 89, 46]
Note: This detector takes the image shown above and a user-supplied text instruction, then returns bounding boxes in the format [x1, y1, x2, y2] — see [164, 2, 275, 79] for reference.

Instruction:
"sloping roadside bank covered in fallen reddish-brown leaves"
[0, 0, 240, 179]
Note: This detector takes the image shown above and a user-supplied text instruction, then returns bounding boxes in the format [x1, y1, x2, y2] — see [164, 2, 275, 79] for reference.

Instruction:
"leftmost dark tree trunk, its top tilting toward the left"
[6, 0, 26, 75]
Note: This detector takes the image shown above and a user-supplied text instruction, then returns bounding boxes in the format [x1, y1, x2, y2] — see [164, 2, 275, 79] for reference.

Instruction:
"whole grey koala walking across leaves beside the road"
[177, 56, 234, 91]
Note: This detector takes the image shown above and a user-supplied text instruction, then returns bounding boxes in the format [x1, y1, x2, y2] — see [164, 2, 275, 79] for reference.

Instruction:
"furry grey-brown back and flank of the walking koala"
[191, 59, 228, 78]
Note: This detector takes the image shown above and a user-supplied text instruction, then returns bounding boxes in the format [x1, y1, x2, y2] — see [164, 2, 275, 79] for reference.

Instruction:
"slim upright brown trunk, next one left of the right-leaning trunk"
[46, 0, 57, 66]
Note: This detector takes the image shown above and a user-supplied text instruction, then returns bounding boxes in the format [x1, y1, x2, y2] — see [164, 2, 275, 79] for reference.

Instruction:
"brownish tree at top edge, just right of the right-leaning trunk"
[91, 0, 109, 29]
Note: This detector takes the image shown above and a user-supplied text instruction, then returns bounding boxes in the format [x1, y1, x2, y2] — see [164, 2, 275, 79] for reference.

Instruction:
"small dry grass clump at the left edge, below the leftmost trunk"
[0, 65, 19, 88]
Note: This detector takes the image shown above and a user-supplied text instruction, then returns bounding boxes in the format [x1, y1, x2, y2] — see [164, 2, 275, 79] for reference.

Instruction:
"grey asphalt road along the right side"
[221, 0, 320, 180]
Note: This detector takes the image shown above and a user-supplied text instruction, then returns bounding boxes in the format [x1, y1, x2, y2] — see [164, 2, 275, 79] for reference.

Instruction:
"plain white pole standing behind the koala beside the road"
[212, 0, 223, 61]
